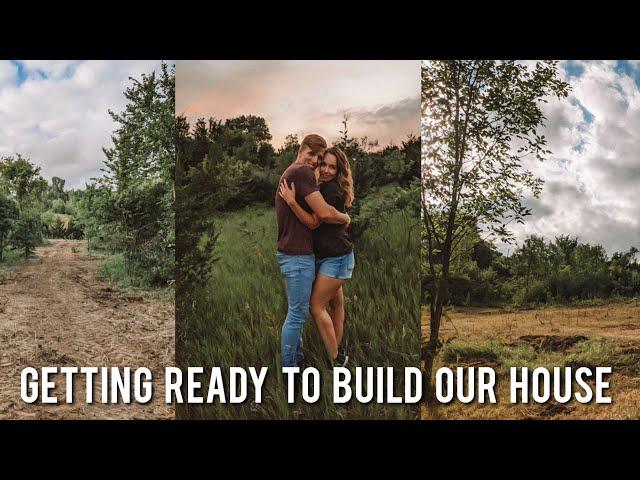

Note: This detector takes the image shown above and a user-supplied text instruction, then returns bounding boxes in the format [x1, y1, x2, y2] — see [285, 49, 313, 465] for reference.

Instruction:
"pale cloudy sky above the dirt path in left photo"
[0, 60, 172, 188]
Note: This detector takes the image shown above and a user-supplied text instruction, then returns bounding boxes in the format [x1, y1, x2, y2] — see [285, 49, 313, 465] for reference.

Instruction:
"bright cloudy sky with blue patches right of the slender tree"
[504, 61, 640, 254]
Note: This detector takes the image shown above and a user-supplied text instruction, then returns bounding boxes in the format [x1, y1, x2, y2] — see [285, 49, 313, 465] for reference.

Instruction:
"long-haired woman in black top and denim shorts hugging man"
[279, 147, 355, 366]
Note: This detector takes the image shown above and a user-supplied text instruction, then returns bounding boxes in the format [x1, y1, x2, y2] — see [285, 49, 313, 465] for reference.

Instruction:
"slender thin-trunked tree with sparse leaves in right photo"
[422, 60, 569, 390]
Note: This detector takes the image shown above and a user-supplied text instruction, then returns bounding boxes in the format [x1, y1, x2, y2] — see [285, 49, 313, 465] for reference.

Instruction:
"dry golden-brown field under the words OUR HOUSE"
[422, 299, 640, 419]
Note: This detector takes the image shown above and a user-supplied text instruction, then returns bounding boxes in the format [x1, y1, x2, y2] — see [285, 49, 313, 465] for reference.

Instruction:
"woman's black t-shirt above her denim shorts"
[313, 180, 353, 258]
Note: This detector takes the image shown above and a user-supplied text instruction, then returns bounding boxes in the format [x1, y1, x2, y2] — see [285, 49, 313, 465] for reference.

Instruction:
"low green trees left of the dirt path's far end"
[0, 154, 83, 261]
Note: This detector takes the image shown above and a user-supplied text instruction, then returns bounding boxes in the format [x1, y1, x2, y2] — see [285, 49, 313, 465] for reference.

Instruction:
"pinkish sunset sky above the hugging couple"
[176, 60, 420, 148]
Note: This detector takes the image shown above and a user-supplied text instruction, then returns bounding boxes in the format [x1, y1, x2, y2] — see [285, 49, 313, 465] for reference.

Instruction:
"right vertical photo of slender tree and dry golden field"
[421, 60, 640, 419]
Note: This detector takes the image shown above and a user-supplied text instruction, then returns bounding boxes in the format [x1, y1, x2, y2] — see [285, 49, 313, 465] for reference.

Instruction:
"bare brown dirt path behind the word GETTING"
[0, 240, 175, 419]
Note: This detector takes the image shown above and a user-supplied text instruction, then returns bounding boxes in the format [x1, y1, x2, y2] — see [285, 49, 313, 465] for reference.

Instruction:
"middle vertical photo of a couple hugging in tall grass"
[176, 61, 420, 419]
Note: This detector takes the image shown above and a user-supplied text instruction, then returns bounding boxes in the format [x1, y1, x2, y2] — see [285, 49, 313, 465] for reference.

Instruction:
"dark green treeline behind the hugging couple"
[176, 115, 420, 285]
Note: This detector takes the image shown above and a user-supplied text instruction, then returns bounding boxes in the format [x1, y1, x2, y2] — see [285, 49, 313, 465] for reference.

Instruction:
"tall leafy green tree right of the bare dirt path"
[81, 63, 176, 285]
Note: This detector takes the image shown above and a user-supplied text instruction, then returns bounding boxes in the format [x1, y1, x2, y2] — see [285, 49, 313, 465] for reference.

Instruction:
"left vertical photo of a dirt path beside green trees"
[0, 60, 175, 420]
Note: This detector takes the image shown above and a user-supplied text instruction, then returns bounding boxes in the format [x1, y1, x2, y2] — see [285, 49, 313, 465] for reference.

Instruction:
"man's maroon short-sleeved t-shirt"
[276, 163, 318, 255]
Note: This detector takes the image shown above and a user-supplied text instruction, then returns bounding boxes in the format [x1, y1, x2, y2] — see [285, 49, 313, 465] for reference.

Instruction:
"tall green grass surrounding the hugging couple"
[176, 206, 420, 419]
